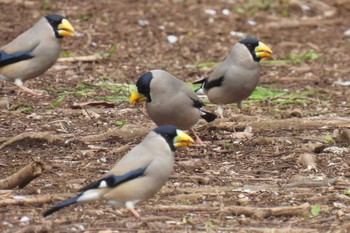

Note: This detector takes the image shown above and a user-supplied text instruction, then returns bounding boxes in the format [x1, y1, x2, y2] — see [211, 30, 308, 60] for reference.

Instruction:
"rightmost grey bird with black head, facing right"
[193, 37, 272, 118]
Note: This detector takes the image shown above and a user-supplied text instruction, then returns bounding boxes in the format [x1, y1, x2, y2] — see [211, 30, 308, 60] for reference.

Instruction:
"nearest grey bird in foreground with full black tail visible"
[43, 125, 194, 218]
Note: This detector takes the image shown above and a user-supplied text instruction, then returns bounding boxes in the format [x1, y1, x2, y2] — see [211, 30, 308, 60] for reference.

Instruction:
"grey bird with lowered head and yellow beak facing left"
[130, 70, 216, 144]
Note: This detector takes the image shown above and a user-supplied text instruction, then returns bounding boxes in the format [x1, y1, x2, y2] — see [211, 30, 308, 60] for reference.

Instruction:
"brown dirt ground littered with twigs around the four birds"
[0, 0, 350, 232]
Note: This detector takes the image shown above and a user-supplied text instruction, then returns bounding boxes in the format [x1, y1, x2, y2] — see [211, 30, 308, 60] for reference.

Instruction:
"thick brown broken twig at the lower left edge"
[0, 161, 45, 189]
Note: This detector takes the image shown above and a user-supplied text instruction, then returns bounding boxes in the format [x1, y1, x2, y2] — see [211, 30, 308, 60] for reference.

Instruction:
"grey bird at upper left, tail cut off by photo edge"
[0, 14, 75, 95]
